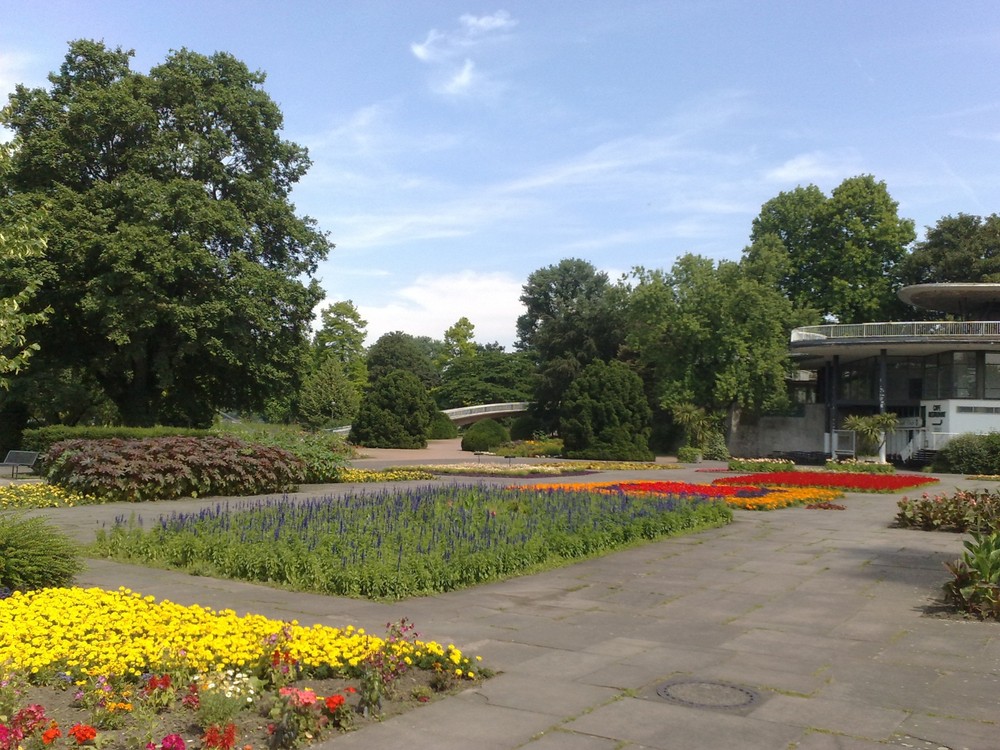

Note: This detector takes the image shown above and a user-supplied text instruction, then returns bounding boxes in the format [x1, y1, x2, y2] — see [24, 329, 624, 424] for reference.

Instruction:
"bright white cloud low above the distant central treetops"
[348, 270, 524, 349]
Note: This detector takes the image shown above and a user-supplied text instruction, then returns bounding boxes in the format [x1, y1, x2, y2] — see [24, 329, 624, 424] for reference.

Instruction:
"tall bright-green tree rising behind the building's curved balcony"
[747, 175, 916, 323]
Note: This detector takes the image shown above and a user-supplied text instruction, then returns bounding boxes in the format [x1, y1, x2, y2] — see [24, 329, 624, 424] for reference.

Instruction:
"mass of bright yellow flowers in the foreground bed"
[0, 587, 475, 679]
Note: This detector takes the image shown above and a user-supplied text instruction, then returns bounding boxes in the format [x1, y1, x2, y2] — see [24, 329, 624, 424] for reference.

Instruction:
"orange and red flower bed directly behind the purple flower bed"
[535, 481, 842, 510]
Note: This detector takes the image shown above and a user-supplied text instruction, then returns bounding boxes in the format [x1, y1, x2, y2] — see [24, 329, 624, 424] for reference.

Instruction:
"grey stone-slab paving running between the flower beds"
[17, 444, 1000, 750]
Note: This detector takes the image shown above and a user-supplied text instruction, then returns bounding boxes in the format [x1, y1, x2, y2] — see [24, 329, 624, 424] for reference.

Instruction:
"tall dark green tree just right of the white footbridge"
[516, 258, 624, 427]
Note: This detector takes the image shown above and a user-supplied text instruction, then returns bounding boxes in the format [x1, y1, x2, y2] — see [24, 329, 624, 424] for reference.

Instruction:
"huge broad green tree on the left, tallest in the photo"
[0, 41, 331, 425]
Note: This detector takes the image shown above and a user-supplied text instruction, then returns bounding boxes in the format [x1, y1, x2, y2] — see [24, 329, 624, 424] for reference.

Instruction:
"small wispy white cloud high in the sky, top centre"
[410, 10, 517, 96]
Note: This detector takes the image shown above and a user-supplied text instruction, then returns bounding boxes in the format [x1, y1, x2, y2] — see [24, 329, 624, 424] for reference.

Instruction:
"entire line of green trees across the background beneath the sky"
[0, 41, 1000, 462]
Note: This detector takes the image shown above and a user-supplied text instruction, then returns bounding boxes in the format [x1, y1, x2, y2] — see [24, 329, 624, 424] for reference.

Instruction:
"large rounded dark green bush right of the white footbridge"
[559, 361, 654, 461]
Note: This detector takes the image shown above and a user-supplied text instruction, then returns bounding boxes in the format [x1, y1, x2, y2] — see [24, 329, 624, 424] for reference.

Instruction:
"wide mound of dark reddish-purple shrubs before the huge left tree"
[45, 436, 305, 502]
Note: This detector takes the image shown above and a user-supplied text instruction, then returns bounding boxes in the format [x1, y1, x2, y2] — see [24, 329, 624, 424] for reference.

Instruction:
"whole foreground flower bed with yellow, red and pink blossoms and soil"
[0, 588, 489, 750]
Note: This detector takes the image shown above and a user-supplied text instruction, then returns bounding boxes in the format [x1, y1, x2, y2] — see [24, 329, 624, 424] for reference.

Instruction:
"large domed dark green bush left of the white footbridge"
[348, 372, 437, 448]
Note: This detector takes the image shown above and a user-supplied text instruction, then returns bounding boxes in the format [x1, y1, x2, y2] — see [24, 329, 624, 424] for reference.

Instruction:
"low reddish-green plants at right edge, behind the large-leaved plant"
[896, 490, 1000, 533]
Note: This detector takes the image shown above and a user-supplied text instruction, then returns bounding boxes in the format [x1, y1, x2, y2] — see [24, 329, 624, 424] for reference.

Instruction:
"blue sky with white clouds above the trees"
[0, 0, 1000, 347]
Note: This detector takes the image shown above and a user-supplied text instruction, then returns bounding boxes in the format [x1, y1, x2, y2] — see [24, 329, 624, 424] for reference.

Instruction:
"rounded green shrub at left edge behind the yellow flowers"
[0, 513, 83, 591]
